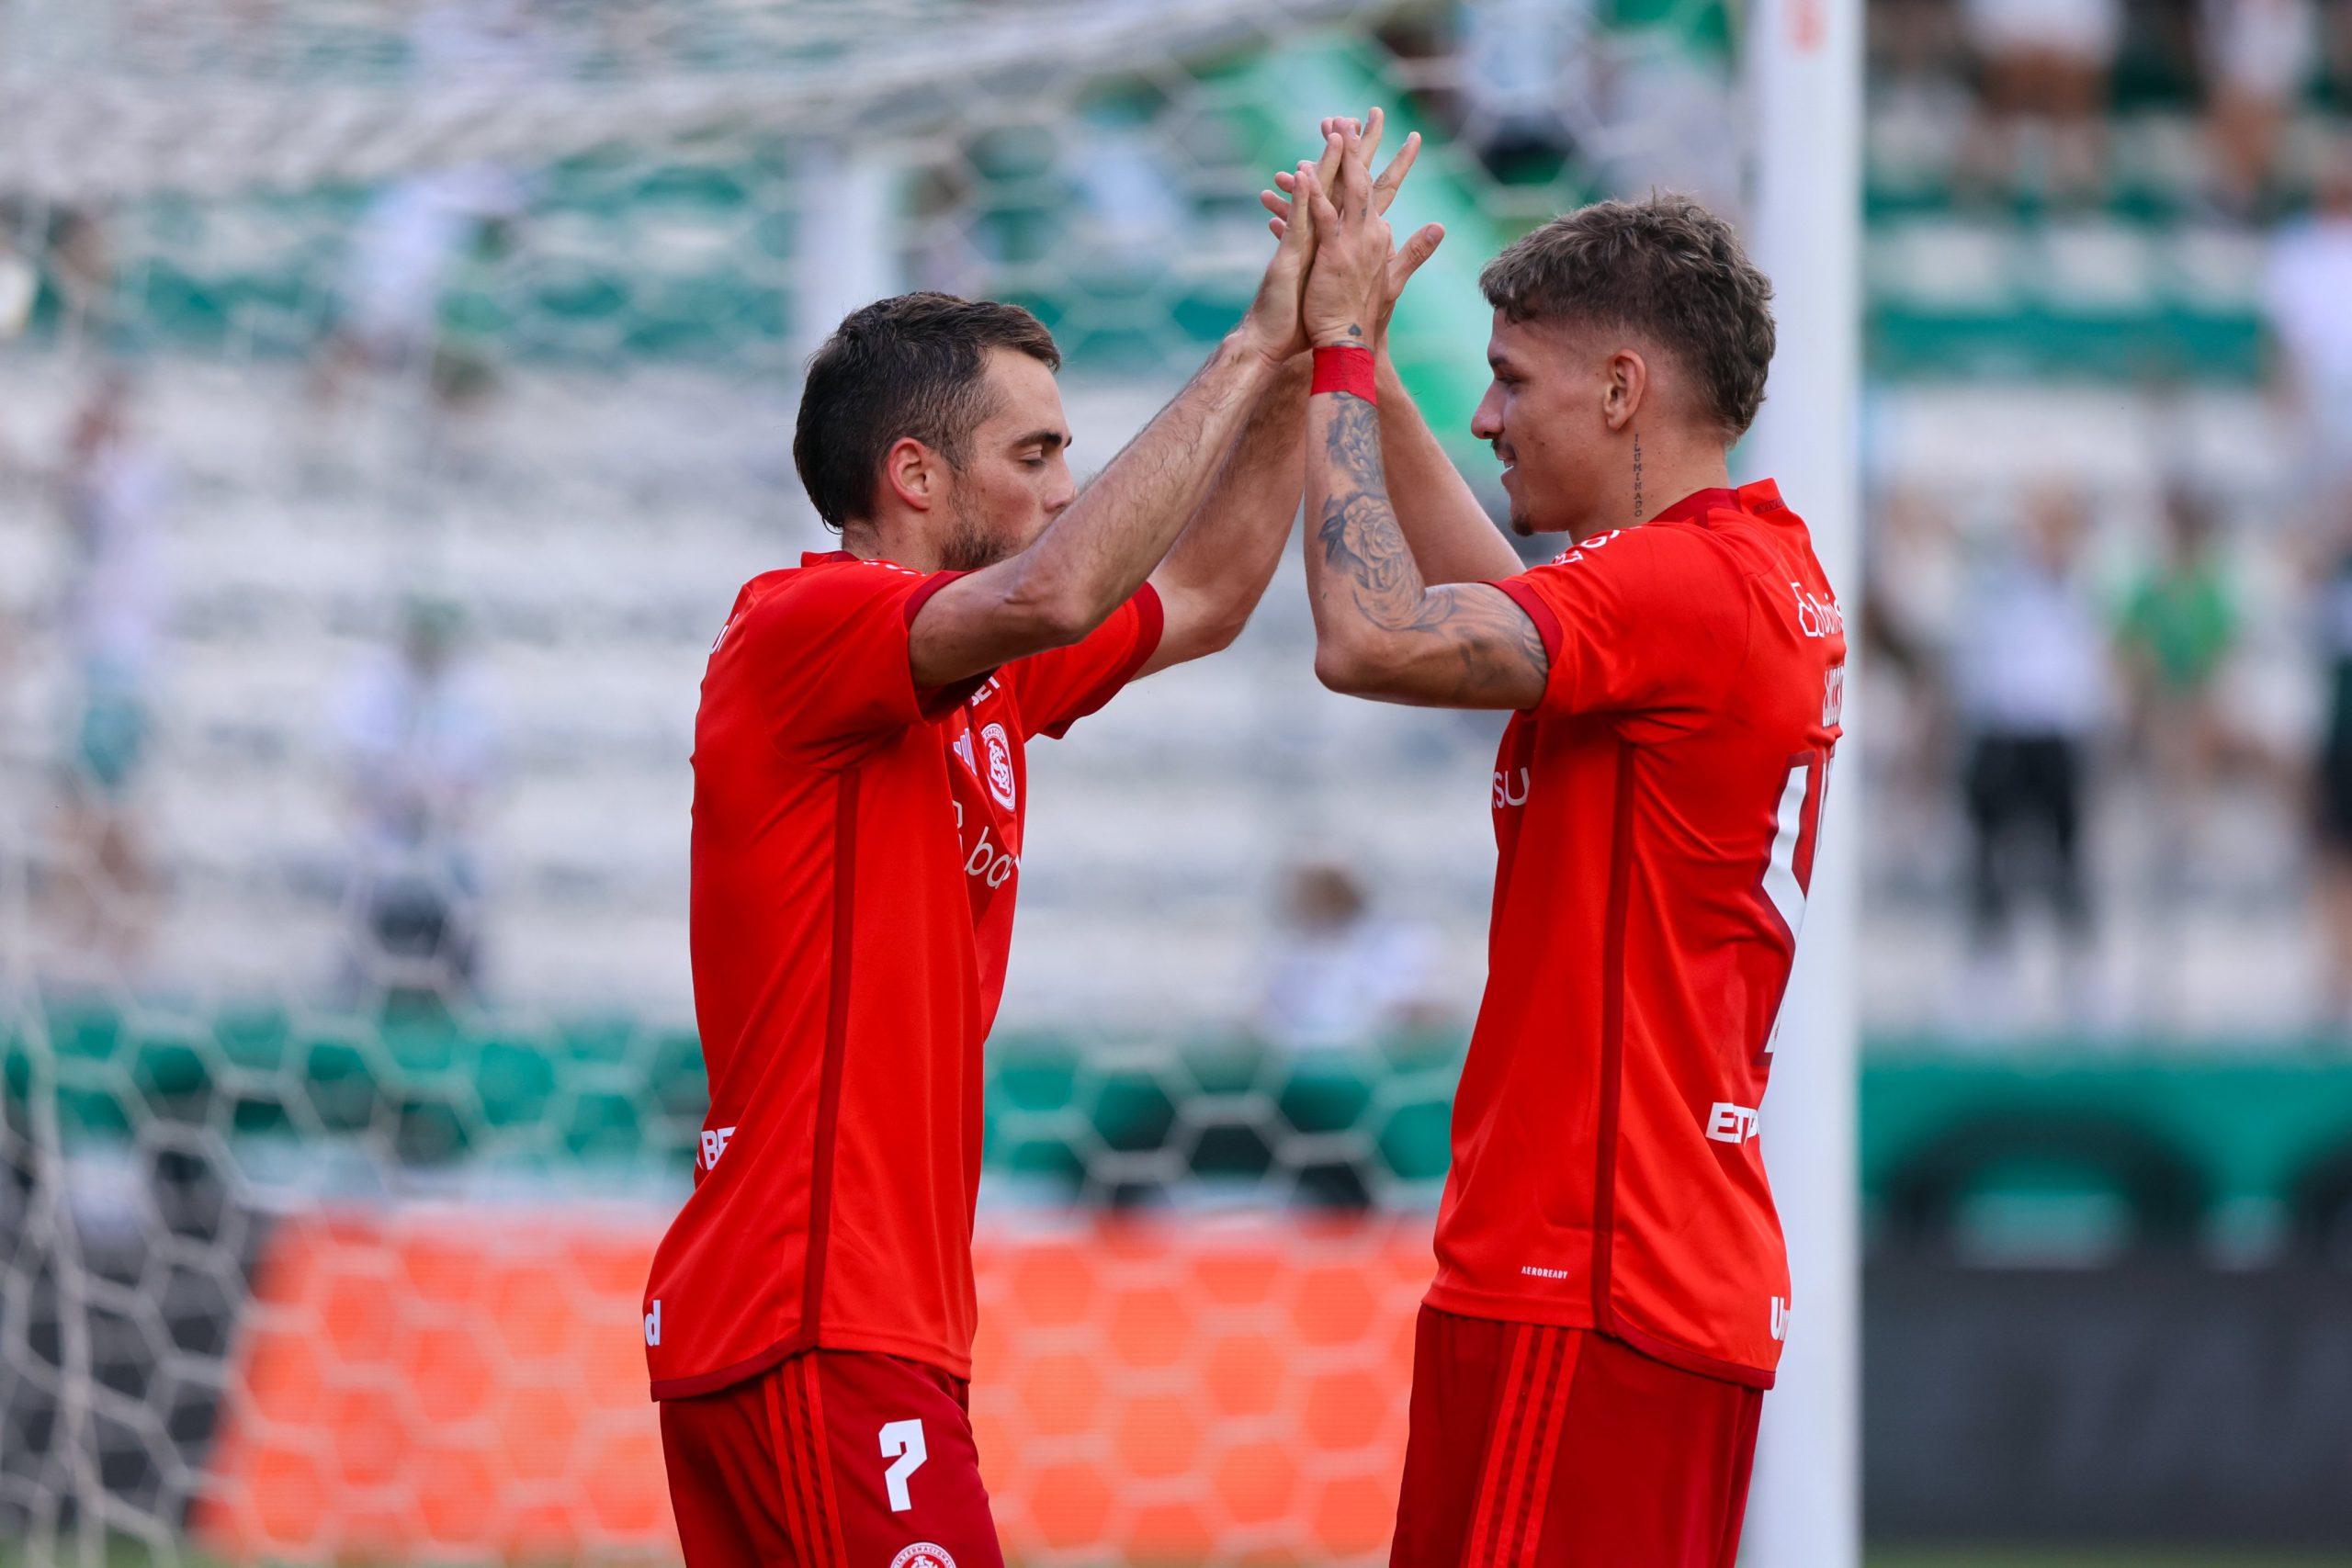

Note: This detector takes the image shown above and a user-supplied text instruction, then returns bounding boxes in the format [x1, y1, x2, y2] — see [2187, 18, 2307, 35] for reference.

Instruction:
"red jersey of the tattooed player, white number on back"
[1428, 482, 1847, 1387]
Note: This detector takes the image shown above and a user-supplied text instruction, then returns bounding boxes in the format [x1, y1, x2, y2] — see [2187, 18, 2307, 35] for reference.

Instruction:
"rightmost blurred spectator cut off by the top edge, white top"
[2199, 0, 2322, 216]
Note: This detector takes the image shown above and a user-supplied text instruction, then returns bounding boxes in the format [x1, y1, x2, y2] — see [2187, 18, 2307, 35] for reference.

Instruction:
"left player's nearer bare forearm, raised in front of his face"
[1016, 333, 1280, 635]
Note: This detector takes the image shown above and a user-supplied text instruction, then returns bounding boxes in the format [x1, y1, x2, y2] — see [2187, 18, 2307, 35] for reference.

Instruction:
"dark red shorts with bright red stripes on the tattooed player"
[1387, 1307, 1764, 1568]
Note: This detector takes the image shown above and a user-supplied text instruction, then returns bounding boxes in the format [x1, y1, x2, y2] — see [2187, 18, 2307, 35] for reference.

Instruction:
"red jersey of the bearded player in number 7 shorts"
[644, 552, 1159, 1399]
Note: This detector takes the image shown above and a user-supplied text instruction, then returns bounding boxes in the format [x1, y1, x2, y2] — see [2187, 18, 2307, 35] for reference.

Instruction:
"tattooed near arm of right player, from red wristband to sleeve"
[1317, 395, 1553, 705]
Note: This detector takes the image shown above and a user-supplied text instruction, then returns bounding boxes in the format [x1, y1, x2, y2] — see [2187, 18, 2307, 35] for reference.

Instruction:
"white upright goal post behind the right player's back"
[1743, 0, 1863, 1568]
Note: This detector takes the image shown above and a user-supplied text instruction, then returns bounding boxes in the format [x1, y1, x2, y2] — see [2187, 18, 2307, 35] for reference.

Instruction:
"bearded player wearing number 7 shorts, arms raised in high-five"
[644, 131, 1411, 1568]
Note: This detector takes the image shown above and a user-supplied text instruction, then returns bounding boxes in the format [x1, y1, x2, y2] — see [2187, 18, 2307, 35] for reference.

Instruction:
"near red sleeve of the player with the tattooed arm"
[1496, 525, 1750, 733]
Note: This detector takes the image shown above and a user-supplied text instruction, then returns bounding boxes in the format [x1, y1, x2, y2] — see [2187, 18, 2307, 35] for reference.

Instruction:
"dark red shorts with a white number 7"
[661, 1349, 1004, 1568]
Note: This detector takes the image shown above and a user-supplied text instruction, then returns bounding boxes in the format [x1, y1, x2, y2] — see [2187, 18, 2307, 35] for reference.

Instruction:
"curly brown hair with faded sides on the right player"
[1477, 193, 1773, 442]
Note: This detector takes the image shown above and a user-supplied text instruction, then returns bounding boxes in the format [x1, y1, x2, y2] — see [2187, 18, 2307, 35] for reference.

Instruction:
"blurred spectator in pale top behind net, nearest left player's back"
[336, 600, 494, 1001]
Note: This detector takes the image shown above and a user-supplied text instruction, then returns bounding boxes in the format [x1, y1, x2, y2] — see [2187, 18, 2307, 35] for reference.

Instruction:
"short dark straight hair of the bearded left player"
[793, 294, 1061, 531]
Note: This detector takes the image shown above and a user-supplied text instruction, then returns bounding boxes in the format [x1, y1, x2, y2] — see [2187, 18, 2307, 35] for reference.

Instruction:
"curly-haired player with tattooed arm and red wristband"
[1298, 122, 1847, 1568]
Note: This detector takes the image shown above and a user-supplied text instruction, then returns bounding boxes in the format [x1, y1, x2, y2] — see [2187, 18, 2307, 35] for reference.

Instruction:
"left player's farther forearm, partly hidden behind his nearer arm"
[1152, 355, 1310, 656]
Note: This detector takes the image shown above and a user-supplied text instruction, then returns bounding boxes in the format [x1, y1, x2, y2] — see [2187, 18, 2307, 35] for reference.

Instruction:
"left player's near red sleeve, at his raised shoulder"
[733, 562, 988, 766]
